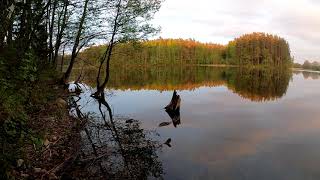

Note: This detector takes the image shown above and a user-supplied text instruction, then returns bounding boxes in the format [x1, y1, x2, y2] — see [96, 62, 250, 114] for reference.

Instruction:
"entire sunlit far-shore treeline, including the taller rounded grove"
[75, 33, 292, 66]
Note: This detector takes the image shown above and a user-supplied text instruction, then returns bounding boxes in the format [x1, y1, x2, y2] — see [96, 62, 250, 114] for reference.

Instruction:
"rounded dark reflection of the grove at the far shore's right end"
[227, 68, 292, 101]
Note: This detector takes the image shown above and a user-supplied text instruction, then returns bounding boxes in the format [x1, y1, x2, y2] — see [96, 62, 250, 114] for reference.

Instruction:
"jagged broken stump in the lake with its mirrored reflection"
[165, 90, 181, 127]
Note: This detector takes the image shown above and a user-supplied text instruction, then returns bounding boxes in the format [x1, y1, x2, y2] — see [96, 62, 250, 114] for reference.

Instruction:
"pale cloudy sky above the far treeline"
[154, 0, 320, 62]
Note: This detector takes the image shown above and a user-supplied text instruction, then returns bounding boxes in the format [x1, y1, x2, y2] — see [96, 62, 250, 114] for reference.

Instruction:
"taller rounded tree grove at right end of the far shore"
[226, 33, 292, 66]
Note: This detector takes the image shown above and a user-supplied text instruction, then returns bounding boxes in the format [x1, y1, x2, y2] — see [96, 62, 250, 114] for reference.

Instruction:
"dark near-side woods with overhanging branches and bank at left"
[0, 0, 162, 179]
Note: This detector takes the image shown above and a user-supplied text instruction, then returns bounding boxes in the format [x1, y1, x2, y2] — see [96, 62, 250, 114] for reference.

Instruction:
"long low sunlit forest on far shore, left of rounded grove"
[75, 38, 224, 65]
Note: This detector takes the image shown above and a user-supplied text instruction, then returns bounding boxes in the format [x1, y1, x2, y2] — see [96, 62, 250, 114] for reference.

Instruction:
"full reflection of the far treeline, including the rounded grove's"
[74, 66, 292, 101]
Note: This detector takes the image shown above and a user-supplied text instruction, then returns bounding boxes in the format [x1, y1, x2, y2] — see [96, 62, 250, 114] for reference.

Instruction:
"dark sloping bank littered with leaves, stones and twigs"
[4, 71, 83, 179]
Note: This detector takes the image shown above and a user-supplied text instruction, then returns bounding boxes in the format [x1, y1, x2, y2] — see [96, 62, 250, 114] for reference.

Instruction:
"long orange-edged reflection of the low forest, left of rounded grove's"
[73, 66, 225, 90]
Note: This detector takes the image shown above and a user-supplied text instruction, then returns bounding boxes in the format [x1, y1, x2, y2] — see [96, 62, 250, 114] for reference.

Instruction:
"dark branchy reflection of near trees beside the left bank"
[68, 94, 163, 179]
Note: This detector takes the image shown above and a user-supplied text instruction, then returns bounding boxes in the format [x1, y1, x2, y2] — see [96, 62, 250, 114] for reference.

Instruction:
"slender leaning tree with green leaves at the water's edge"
[94, 0, 161, 97]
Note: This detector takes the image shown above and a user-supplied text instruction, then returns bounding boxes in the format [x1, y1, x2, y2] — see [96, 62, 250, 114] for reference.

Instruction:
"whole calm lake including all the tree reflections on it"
[71, 66, 320, 180]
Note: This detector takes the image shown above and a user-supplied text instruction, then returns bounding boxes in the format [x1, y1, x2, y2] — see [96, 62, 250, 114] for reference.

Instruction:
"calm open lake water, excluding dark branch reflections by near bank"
[70, 67, 320, 180]
